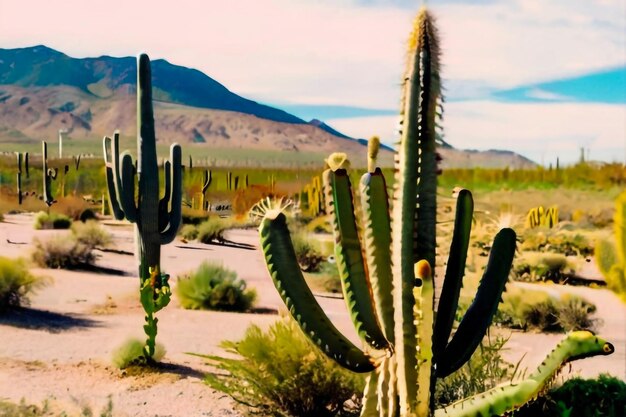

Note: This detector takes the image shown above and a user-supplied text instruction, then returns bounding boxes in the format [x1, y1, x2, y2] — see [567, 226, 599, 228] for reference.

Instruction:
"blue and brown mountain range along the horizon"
[0, 45, 532, 167]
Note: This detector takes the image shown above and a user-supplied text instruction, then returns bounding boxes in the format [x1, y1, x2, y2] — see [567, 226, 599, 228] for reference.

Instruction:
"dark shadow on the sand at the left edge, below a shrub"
[0, 307, 100, 333]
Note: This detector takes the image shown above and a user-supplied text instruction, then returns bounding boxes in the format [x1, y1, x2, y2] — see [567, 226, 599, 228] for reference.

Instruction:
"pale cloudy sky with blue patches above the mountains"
[0, 0, 626, 165]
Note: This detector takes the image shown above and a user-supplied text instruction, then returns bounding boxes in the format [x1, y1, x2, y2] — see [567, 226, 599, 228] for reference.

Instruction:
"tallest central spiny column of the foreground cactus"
[392, 10, 438, 416]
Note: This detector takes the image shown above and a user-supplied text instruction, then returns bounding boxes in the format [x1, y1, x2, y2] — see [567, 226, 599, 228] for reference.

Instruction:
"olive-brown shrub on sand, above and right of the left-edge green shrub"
[32, 235, 95, 269]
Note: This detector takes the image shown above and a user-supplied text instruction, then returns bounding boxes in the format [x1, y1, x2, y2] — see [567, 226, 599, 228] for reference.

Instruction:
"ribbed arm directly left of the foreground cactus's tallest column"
[360, 168, 394, 340]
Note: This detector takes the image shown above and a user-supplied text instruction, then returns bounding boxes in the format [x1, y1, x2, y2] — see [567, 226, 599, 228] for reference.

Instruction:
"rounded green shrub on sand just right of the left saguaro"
[176, 262, 256, 311]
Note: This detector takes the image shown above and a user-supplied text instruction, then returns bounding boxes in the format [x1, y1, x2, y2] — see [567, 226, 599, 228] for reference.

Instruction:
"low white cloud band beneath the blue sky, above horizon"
[328, 101, 626, 164]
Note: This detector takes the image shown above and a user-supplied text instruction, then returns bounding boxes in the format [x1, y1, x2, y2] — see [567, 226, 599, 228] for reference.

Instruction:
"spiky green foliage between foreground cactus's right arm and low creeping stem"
[435, 335, 519, 407]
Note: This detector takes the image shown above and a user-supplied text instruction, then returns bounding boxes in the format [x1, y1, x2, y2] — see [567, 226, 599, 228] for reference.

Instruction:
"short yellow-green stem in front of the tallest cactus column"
[413, 260, 434, 416]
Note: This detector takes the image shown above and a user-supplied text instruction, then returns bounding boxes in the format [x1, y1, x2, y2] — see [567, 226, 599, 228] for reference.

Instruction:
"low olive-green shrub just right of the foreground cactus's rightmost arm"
[494, 288, 596, 332]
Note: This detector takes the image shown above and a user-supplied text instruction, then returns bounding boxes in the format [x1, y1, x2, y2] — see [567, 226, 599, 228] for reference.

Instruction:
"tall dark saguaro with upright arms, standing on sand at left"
[103, 54, 182, 361]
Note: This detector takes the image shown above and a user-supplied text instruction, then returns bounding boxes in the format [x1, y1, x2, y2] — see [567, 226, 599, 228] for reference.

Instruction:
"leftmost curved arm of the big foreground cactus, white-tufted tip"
[259, 210, 374, 372]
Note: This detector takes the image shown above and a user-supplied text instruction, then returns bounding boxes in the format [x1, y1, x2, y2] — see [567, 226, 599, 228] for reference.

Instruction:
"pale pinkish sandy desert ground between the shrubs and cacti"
[0, 215, 626, 417]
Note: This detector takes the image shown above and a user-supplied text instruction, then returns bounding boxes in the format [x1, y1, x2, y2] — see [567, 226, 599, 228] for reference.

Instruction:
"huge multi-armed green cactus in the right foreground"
[259, 7, 612, 417]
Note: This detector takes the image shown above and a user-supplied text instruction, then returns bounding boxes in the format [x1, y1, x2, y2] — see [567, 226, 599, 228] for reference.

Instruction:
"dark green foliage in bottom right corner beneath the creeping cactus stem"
[513, 374, 626, 417]
